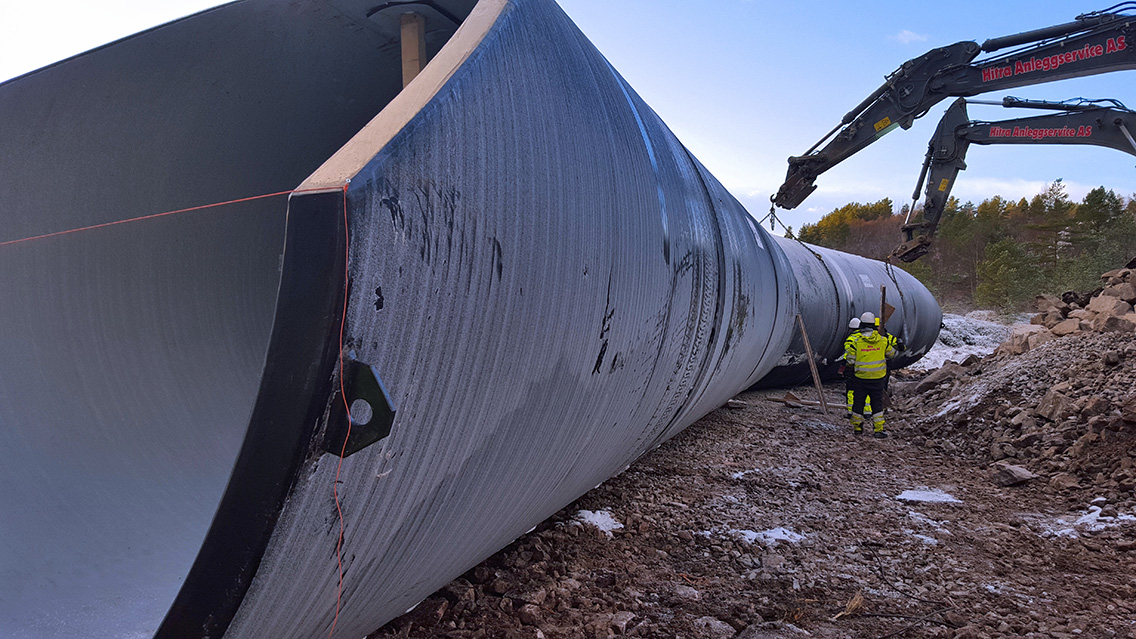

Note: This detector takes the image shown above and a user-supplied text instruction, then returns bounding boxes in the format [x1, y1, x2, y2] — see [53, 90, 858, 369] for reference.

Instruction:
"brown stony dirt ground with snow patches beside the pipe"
[371, 358, 1136, 639]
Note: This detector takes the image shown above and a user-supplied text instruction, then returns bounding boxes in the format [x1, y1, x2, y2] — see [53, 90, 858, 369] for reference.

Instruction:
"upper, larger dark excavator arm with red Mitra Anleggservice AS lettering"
[770, 1, 1136, 242]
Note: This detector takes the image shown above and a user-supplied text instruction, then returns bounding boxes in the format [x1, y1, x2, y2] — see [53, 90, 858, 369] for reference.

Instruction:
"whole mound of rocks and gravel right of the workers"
[896, 261, 1136, 506]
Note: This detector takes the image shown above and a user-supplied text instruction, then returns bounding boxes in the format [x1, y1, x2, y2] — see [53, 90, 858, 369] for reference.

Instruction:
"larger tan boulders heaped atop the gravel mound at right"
[1001, 263, 1136, 355]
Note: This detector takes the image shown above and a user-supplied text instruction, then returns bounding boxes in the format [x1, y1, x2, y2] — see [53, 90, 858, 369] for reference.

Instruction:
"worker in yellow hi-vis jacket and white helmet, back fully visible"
[844, 313, 899, 439]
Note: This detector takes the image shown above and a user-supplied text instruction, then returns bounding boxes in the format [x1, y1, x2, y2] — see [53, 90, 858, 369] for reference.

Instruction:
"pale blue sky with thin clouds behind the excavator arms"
[0, 0, 1136, 234]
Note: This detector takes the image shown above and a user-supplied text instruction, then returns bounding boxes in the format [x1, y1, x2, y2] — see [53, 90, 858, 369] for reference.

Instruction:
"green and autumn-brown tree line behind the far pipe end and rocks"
[788, 180, 1136, 312]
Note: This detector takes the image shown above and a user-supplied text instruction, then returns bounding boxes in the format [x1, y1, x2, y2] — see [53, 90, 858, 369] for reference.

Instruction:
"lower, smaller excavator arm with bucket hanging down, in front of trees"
[892, 97, 1136, 262]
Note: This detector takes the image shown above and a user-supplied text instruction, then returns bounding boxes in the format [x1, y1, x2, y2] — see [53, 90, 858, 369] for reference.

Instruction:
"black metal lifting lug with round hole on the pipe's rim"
[320, 358, 395, 457]
